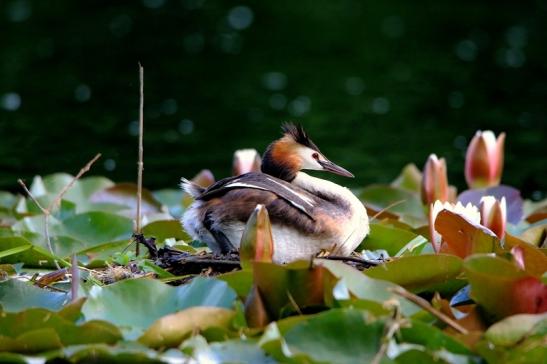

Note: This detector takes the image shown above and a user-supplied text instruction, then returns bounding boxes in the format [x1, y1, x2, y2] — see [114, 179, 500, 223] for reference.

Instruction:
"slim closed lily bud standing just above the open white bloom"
[422, 154, 449, 205]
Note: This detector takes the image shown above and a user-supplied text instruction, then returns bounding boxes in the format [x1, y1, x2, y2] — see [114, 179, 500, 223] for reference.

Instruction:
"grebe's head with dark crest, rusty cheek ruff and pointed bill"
[262, 123, 353, 181]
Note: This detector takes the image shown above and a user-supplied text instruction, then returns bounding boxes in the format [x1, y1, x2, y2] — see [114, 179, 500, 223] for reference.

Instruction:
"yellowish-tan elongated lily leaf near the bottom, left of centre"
[139, 306, 235, 348]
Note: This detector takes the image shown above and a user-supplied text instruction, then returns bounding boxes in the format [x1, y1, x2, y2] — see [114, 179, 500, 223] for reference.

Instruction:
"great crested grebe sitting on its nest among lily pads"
[181, 123, 369, 263]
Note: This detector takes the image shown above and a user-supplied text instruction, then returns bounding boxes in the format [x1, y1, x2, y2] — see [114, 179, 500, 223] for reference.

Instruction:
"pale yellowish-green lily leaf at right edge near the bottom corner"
[484, 313, 547, 346]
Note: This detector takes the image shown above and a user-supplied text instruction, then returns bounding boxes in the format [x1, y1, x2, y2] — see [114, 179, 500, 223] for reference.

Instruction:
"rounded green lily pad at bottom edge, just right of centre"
[284, 309, 384, 363]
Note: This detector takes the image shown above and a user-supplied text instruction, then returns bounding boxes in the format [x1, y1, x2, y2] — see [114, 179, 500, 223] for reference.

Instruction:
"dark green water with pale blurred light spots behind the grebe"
[0, 0, 547, 198]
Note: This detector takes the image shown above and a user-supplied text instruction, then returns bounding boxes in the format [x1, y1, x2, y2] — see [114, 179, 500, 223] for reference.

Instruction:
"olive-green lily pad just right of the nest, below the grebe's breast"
[364, 254, 465, 293]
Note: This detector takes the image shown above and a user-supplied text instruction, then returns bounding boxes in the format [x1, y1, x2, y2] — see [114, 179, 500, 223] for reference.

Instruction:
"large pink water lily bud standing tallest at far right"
[465, 130, 505, 188]
